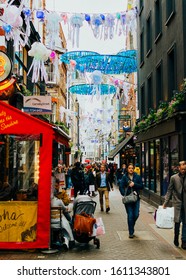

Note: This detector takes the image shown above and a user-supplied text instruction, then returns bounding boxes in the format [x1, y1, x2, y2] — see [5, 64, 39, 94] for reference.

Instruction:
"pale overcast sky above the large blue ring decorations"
[47, 0, 127, 54]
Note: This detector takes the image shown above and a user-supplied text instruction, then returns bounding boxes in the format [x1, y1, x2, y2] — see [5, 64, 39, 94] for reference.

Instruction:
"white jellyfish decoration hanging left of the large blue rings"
[27, 42, 51, 83]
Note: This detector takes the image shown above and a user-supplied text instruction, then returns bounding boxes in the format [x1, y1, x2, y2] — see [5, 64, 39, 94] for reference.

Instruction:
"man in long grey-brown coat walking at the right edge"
[163, 161, 186, 250]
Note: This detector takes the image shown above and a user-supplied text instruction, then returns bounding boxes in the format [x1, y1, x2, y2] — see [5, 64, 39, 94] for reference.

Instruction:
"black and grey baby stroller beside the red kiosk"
[72, 195, 100, 249]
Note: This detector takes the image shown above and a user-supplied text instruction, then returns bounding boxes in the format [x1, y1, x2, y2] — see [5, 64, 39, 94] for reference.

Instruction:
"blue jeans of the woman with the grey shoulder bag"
[125, 199, 140, 235]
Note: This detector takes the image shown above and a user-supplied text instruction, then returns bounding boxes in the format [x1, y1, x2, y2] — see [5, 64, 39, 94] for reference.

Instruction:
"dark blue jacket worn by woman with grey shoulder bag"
[119, 172, 143, 197]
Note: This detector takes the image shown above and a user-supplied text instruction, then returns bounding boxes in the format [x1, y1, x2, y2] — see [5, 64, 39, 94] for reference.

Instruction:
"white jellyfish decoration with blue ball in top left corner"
[2, 5, 25, 48]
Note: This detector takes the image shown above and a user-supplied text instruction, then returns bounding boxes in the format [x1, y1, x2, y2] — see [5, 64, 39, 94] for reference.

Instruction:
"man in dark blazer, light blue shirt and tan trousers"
[96, 164, 114, 213]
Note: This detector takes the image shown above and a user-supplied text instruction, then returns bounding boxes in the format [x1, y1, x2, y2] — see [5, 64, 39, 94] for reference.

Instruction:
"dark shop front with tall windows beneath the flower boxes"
[135, 113, 186, 205]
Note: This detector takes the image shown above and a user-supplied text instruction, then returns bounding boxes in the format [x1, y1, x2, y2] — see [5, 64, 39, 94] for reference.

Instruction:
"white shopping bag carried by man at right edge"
[156, 206, 174, 228]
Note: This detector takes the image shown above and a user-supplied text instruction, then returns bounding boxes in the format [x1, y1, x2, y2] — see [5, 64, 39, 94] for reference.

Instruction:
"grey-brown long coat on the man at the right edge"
[164, 173, 186, 223]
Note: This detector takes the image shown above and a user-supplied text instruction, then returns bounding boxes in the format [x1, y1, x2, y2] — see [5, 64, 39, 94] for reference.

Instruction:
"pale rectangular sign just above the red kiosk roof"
[23, 95, 52, 115]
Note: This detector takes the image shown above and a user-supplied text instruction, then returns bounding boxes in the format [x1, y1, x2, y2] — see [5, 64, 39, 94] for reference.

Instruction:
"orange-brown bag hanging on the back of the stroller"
[73, 212, 96, 236]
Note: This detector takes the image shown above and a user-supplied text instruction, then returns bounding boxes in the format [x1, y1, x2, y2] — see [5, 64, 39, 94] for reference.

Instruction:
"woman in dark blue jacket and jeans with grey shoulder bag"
[119, 163, 143, 238]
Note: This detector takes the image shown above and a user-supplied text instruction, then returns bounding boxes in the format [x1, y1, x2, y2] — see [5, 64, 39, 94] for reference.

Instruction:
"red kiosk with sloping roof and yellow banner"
[0, 101, 68, 249]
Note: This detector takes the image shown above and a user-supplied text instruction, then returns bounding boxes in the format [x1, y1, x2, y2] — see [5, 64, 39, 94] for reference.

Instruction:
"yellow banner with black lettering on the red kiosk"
[0, 201, 37, 242]
